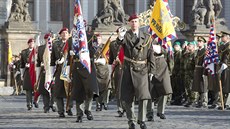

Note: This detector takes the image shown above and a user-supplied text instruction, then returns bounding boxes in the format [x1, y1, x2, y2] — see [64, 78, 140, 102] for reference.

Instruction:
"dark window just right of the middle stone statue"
[124, 0, 136, 15]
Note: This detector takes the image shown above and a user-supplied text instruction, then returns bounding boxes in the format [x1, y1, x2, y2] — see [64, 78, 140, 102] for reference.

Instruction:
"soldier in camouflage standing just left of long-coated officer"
[183, 41, 199, 107]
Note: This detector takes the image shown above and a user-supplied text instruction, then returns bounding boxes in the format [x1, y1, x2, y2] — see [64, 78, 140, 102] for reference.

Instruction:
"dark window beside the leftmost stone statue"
[50, 0, 64, 21]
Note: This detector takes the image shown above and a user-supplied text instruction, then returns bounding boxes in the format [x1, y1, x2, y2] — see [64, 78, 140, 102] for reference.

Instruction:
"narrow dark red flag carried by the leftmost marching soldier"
[29, 48, 36, 89]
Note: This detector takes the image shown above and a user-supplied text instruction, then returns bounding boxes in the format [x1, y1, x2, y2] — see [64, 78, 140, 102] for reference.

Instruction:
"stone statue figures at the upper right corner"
[192, 0, 223, 27]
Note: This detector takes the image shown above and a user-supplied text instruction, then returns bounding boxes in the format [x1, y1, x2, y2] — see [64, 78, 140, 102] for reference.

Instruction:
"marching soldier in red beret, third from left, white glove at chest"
[51, 27, 73, 117]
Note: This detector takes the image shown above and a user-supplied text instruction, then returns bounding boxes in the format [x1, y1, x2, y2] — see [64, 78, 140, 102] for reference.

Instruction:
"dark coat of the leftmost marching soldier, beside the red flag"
[21, 48, 33, 90]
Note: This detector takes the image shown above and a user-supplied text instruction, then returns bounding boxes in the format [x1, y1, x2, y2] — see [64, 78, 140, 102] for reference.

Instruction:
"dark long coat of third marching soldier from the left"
[51, 40, 66, 98]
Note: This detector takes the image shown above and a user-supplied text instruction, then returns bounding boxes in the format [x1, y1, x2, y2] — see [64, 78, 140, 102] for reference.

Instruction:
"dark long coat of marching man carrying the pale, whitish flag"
[36, 44, 49, 95]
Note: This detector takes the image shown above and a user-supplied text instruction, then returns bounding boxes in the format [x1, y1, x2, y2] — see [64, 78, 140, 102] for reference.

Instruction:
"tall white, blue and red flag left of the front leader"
[72, 0, 91, 73]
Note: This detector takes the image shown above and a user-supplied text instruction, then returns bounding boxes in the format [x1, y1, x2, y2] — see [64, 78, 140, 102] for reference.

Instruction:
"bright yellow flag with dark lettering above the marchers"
[150, 0, 175, 40]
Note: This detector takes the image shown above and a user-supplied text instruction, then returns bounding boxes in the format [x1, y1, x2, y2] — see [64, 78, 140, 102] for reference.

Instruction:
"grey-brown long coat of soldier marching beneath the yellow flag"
[150, 54, 172, 99]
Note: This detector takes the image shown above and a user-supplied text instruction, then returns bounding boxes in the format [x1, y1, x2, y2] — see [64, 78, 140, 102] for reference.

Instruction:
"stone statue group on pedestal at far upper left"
[8, 0, 31, 22]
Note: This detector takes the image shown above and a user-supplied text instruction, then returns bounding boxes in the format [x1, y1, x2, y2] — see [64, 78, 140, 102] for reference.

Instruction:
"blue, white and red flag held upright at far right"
[204, 20, 219, 75]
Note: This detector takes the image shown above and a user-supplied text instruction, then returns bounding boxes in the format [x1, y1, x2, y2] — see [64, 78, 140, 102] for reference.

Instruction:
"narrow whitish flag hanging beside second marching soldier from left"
[43, 36, 52, 95]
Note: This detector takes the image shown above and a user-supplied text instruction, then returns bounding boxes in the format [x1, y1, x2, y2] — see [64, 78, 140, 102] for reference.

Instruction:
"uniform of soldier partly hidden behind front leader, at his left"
[109, 41, 124, 117]
